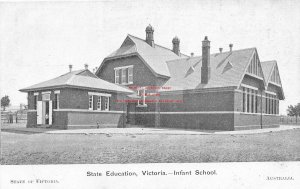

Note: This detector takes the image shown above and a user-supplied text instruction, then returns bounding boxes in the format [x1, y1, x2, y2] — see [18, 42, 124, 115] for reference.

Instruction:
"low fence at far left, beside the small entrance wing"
[1, 111, 27, 124]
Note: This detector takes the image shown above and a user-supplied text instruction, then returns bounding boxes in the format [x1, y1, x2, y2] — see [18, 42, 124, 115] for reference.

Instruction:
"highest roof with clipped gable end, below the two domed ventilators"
[96, 34, 188, 77]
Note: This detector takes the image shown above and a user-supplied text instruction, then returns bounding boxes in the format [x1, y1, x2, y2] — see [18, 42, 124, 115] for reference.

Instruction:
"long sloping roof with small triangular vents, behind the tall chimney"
[164, 48, 256, 90]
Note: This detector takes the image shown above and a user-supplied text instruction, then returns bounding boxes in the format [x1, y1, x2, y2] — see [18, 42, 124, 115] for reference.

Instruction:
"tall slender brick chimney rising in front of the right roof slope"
[201, 36, 210, 84]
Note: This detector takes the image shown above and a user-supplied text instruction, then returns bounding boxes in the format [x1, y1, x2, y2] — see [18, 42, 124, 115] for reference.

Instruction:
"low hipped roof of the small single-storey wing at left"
[20, 70, 133, 93]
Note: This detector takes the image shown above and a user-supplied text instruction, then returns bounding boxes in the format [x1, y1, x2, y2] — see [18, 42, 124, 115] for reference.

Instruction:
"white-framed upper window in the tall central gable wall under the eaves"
[115, 65, 133, 85]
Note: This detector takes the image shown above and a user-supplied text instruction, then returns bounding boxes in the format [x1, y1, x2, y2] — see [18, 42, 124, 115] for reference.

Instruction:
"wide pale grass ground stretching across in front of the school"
[1, 129, 300, 164]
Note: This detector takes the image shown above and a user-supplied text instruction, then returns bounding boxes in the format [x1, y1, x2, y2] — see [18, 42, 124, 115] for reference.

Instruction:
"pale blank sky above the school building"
[0, 0, 300, 114]
